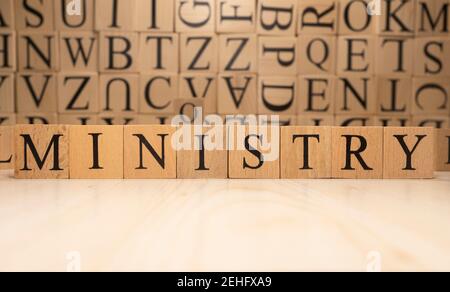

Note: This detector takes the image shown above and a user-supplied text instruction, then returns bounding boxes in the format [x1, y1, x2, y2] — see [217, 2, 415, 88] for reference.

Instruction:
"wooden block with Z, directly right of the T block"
[180, 33, 219, 73]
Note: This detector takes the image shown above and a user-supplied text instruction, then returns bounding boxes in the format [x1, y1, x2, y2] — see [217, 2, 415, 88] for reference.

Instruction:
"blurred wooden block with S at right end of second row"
[414, 37, 450, 77]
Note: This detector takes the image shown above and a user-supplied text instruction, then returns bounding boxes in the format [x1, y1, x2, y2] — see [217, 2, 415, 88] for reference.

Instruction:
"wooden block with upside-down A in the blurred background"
[217, 73, 258, 114]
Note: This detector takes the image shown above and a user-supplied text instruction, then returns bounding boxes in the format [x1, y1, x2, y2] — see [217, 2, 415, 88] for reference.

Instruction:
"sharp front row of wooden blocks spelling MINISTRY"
[0, 125, 450, 179]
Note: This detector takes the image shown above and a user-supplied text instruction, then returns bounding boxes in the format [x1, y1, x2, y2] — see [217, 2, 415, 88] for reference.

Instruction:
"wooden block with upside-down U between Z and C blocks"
[100, 74, 139, 114]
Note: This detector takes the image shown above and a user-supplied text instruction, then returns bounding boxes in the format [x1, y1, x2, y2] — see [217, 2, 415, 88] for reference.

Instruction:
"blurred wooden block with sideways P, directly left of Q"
[258, 37, 298, 76]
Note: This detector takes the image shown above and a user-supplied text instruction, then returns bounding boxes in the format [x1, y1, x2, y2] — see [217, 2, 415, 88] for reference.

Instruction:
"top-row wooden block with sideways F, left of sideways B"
[216, 0, 256, 33]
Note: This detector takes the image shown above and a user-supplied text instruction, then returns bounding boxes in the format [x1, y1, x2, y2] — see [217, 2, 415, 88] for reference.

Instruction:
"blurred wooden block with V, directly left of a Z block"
[16, 72, 58, 113]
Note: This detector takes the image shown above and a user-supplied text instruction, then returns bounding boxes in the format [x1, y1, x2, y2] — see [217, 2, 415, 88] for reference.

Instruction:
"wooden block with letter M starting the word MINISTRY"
[14, 125, 69, 179]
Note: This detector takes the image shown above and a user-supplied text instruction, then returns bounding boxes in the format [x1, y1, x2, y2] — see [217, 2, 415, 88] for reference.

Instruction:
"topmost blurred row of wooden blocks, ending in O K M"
[0, 0, 450, 36]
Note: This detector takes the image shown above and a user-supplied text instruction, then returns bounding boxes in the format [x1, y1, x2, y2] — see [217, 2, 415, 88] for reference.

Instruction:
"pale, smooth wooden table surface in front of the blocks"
[0, 171, 450, 271]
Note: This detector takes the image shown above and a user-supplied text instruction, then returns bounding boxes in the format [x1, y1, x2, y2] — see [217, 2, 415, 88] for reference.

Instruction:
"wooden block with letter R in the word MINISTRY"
[332, 127, 383, 179]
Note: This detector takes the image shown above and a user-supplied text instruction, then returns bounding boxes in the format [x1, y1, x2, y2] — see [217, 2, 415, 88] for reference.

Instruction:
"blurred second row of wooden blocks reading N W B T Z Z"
[0, 31, 450, 77]
